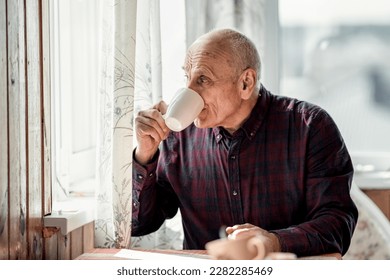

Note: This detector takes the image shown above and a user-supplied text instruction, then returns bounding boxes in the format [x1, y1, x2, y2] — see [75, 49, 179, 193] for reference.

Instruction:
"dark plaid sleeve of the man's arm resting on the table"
[273, 109, 358, 256]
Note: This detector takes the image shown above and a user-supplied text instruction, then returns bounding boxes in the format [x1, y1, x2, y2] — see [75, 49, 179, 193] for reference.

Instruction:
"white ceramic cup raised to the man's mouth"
[164, 88, 204, 132]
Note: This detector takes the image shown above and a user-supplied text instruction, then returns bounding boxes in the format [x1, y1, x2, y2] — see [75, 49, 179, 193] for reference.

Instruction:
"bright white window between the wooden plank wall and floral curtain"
[50, 0, 100, 202]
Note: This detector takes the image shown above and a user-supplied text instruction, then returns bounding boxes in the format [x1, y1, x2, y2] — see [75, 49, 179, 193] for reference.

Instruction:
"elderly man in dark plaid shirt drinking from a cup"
[132, 29, 358, 256]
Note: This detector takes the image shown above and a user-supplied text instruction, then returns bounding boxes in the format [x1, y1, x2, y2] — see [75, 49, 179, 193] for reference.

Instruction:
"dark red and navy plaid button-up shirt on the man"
[132, 87, 358, 256]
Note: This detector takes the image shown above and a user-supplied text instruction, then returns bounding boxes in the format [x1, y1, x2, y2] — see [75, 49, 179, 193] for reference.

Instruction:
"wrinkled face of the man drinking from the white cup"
[184, 39, 242, 128]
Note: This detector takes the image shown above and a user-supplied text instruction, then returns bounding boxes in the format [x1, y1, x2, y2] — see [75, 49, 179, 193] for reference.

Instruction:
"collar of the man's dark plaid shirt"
[213, 85, 271, 143]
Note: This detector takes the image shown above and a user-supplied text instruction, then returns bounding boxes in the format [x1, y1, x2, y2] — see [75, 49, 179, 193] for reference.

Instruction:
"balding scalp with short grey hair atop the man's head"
[190, 29, 261, 81]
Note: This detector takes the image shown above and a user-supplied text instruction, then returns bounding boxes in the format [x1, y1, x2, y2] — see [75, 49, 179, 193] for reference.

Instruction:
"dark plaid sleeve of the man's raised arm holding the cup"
[131, 151, 178, 236]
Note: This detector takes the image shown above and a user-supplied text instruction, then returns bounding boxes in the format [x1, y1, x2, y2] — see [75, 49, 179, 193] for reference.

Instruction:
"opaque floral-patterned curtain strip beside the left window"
[95, 0, 137, 248]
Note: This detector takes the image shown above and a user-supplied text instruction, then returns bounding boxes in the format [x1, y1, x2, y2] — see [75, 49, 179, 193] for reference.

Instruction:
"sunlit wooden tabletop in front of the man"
[76, 248, 342, 260]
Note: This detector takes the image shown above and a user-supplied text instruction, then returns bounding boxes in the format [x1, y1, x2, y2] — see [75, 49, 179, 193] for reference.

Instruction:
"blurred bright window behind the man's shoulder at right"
[279, 0, 390, 176]
